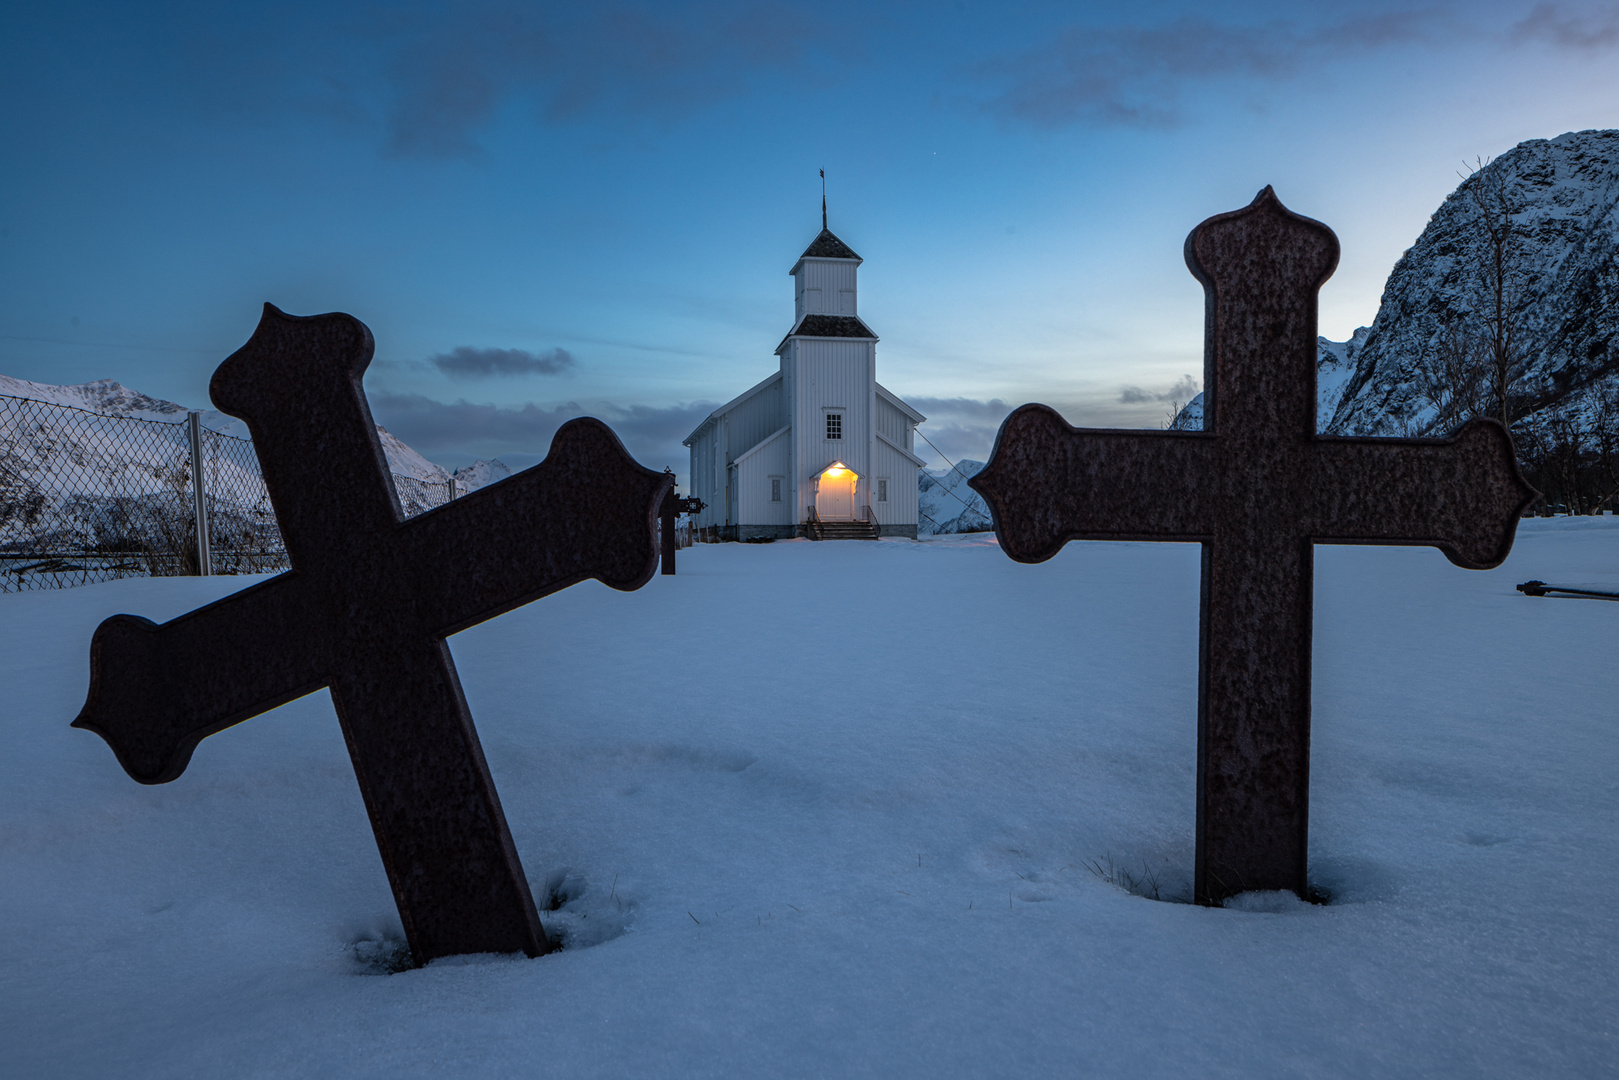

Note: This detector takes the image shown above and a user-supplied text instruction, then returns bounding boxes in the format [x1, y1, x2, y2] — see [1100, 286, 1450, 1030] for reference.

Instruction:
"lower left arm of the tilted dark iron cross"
[73, 572, 330, 784]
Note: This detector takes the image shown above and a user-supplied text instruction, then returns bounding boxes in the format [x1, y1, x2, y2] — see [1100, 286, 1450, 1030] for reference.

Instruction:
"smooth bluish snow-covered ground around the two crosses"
[0, 518, 1619, 1078]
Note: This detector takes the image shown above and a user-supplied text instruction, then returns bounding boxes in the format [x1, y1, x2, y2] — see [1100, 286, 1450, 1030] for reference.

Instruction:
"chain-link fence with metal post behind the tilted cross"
[0, 395, 458, 593]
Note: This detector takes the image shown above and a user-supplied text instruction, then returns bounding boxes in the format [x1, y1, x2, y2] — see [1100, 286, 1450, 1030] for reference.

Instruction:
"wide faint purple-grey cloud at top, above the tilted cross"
[178, 0, 848, 159]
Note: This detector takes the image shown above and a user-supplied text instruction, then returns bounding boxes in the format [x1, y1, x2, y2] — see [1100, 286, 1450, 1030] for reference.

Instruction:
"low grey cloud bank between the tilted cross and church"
[369, 392, 716, 470]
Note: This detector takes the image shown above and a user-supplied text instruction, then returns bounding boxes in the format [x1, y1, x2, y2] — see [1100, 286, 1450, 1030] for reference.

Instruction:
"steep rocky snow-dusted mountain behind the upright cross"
[1172, 130, 1619, 436]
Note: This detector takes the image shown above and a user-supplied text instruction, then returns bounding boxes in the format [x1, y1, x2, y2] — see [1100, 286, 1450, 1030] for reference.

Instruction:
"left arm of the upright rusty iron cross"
[967, 405, 1216, 562]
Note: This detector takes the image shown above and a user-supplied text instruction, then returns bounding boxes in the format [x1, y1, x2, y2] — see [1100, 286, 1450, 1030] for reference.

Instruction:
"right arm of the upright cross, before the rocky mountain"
[1310, 419, 1540, 570]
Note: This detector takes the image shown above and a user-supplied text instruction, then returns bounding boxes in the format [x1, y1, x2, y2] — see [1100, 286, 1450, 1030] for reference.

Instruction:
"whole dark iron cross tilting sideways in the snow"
[73, 304, 670, 963]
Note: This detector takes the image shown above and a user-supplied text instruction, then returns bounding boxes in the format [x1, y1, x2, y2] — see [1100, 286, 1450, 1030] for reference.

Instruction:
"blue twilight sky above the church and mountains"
[0, 0, 1619, 473]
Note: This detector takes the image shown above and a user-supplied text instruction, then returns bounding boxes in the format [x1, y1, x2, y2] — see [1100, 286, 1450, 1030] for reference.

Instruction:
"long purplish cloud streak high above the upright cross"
[978, 10, 1441, 128]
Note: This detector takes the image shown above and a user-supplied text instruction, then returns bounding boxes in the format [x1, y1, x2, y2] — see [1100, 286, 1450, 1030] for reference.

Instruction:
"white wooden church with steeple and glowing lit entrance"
[683, 220, 926, 539]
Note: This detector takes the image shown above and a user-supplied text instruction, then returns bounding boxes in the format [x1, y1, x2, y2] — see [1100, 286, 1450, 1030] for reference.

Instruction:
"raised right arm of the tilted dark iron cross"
[398, 416, 674, 635]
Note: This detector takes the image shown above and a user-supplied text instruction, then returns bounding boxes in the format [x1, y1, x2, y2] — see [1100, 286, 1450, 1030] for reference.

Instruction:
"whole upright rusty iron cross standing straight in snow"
[970, 188, 1535, 904]
